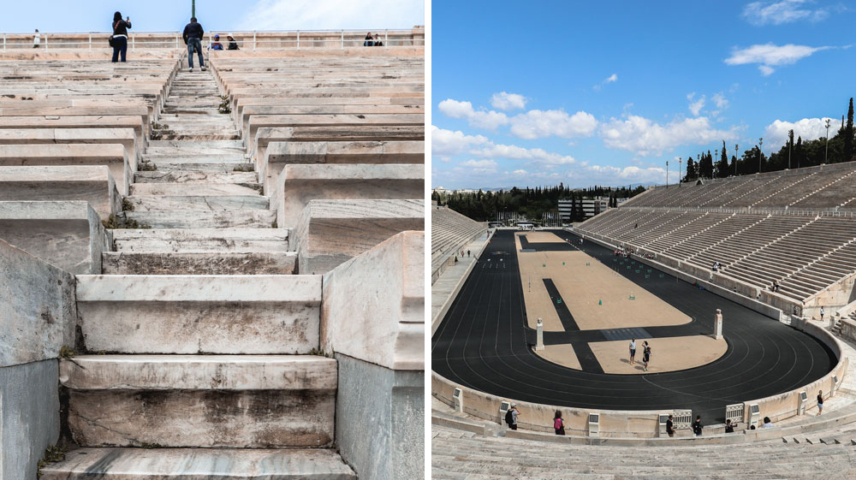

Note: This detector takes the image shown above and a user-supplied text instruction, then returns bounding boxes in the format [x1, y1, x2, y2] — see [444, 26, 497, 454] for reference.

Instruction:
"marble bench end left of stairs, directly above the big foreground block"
[0, 201, 109, 274]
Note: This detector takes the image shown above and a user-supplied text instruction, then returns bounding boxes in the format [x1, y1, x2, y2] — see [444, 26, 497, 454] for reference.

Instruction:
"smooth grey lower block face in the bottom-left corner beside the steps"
[0, 360, 60, 480]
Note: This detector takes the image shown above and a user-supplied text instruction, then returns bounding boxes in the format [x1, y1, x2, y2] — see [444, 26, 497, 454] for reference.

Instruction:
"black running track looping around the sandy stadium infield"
[431, 230, 836, 423]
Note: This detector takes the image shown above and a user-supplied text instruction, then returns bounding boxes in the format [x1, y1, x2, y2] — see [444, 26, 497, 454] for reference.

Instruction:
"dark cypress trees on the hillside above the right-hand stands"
[681, 98, 856, 182]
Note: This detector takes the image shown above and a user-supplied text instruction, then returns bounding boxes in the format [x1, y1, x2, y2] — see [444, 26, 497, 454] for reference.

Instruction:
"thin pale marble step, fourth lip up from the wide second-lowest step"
[122, 210, 276, 229]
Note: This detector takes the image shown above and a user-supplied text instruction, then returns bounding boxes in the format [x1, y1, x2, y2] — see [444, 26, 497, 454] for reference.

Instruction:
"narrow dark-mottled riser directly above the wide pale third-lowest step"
[101, 249, 297, 275]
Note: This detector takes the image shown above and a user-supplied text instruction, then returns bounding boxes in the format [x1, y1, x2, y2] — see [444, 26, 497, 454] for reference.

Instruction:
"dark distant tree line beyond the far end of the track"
[431, 183, 645, 223]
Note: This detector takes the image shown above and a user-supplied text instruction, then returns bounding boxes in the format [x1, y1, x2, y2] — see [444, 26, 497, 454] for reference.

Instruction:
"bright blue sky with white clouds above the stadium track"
[431, 0, 856, 188]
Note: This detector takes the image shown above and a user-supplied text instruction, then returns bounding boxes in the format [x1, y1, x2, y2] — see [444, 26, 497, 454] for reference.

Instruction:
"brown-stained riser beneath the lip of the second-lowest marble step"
[68, 390, 336, 448]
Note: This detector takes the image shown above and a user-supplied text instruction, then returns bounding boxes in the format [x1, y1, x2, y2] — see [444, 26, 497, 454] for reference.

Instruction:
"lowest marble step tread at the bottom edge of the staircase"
[41, 448, 357, 480]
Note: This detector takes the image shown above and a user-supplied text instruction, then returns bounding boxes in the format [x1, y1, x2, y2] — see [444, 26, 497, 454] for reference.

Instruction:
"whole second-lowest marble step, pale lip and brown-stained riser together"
[60, 355, 337, 448]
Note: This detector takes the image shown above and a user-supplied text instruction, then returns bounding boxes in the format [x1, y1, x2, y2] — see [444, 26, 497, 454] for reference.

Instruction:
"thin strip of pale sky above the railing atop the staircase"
[0, 0, 425, 33]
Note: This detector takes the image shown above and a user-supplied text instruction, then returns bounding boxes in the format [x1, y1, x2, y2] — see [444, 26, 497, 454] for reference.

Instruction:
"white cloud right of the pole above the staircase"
[235, 0, 425, 32]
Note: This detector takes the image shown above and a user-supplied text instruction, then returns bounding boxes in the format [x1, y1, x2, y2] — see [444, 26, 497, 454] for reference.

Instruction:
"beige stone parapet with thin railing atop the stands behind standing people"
[0, 26, 425, 52]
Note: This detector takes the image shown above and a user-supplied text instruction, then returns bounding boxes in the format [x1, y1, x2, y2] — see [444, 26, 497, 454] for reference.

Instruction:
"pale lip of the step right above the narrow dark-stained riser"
[113, 228, 293, 253]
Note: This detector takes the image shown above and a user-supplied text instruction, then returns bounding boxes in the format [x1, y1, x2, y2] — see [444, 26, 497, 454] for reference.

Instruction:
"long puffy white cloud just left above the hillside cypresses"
[600, 115, 738, 157]
